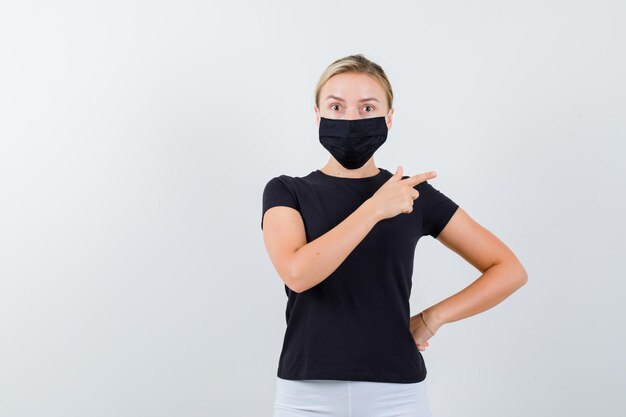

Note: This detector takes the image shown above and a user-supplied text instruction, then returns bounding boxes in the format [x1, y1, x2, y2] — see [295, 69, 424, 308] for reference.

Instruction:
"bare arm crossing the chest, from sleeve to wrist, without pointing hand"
[263, 200, 381, 292]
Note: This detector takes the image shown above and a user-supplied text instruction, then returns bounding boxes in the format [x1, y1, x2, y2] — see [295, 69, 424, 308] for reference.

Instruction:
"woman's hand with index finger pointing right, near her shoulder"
[368, 165, 437, 220]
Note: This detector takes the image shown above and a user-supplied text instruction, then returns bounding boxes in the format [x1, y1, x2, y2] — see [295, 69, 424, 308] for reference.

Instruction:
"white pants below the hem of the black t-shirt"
[273, 377, 432, 417]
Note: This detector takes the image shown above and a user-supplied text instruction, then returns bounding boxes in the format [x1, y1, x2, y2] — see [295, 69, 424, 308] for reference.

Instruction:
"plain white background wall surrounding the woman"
[0, 0, 626, 417]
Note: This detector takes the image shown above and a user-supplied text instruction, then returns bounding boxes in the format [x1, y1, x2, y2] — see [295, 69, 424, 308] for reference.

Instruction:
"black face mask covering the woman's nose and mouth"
[319, 116, 387, 169]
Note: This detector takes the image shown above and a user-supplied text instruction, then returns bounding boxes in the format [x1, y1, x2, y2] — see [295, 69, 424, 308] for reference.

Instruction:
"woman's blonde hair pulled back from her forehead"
[315, 54, 393, 109]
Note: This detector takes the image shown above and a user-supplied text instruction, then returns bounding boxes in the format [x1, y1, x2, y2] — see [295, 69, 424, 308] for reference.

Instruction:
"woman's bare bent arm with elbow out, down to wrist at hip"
[412, 207, 528, 333]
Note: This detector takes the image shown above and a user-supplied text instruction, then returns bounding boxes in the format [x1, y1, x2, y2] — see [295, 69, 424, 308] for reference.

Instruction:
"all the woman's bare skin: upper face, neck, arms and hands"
[263, 72, 528, 351]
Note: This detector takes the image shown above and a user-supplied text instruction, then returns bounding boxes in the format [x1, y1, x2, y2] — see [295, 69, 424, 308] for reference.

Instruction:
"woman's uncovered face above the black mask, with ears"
[314, 72, 393, 129]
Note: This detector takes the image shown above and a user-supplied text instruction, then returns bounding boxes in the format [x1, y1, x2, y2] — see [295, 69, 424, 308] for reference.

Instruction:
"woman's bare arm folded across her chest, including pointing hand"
[263, 167, 434, 293]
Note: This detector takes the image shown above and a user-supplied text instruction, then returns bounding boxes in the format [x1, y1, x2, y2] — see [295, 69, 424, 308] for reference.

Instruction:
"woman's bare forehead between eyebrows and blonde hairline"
[320, 72, 385, 101]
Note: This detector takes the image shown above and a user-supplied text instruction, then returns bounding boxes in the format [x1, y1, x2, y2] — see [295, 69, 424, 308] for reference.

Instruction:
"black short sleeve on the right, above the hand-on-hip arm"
[416, 181, 459, 238]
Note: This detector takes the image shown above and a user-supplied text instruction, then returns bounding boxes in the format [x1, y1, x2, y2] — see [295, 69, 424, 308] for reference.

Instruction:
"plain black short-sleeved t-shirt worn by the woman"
[261, 168, 459, 383]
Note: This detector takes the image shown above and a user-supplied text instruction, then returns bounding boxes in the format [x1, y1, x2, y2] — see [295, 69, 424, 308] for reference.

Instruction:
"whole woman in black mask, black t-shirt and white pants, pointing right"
[261, 54, 527, 417]
